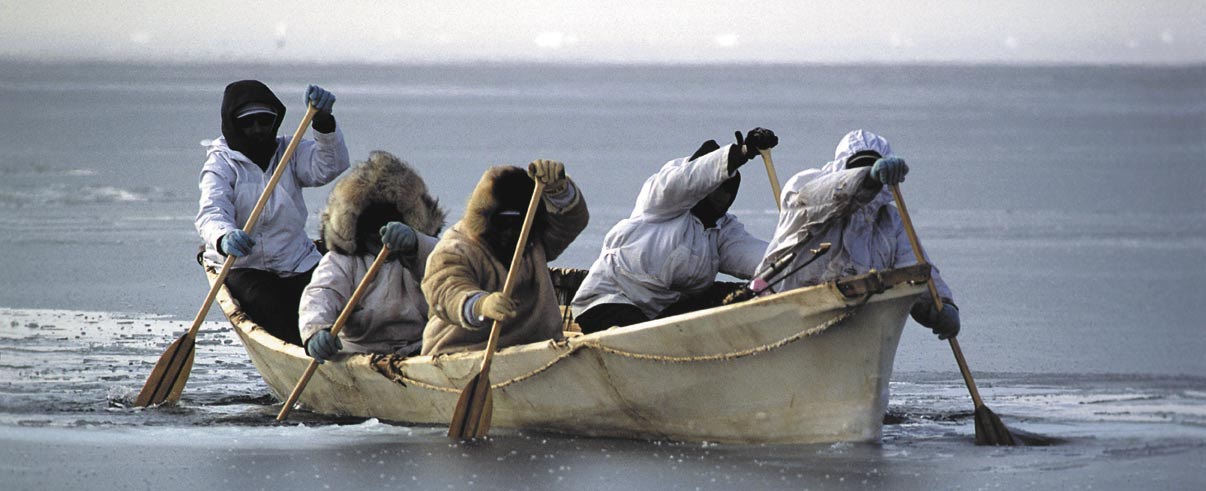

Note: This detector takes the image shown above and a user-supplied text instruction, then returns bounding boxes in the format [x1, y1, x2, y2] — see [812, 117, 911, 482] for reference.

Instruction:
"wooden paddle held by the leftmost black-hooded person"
[134, 105, 318, 407]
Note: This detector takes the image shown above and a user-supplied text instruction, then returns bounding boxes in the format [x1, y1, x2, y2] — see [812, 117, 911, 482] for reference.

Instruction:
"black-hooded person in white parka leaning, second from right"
[572, 128, 779, 333]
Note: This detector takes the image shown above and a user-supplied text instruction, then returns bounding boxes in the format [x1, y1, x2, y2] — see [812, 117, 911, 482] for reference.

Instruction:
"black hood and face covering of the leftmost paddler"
[222, 80, 285, 170]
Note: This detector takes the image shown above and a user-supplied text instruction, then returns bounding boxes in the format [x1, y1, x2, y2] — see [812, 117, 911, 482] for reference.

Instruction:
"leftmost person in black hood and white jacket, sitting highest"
[195, 80, 351, 345]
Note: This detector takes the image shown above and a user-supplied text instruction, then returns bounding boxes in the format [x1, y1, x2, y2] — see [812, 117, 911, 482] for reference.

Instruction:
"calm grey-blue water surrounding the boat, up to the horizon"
[0, 63, 1206, 489]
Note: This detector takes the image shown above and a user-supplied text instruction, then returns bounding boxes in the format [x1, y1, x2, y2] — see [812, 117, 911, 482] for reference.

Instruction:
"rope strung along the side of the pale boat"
[373, 305, 871, 393]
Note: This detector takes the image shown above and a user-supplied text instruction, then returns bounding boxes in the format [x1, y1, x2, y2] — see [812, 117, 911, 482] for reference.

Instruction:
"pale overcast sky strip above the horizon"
[0, 0, 1206, 64]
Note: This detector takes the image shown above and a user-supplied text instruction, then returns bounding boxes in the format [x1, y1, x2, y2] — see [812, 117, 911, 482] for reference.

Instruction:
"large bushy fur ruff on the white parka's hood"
[321, 150, 446, 255]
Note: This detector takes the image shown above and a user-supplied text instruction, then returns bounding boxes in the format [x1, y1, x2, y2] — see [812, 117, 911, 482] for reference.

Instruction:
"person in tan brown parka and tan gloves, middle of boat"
[422, 160, 590, 355]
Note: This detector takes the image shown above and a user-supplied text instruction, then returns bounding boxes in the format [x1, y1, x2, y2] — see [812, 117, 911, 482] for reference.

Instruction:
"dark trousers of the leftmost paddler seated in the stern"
[227, 268, 314, 346]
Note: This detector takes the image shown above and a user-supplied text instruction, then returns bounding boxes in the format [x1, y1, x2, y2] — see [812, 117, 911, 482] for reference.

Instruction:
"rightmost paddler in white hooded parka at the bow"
[757, 129, 959, 339]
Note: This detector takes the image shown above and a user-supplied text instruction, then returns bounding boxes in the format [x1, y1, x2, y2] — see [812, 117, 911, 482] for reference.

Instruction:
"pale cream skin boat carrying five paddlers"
[209, 264, 930, 444]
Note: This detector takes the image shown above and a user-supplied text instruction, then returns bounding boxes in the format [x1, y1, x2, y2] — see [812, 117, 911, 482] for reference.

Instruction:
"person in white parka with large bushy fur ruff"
[299, 151, 445, 361]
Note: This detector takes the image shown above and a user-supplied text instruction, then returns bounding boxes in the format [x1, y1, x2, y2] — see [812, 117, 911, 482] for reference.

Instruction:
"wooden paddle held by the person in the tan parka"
[449, 180, 544, 440]
